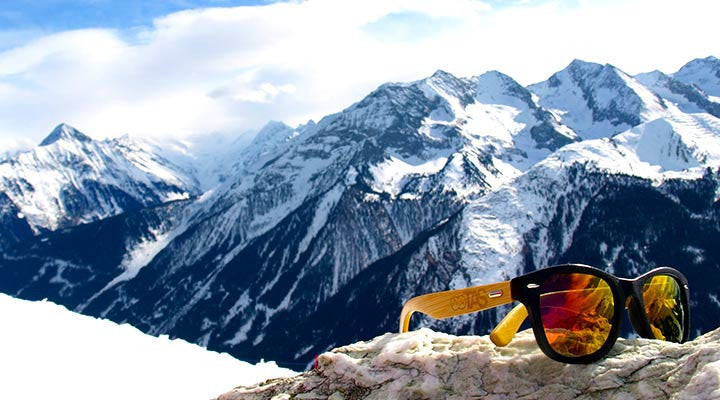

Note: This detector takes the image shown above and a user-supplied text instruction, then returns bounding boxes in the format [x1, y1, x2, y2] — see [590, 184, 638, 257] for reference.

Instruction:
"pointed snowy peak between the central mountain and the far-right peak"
[528, 60, 667, 139]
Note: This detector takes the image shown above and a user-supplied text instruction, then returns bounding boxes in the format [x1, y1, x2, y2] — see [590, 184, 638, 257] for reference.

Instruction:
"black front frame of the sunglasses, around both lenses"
[510, 264, 690, 364]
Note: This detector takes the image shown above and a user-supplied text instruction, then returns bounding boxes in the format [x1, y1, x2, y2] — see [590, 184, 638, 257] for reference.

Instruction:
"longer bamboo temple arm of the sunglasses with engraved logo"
[400, 281, 513, 333]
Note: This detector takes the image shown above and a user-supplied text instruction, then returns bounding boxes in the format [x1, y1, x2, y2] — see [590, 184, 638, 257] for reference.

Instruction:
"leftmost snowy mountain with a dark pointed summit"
[0, 124, 198, 246]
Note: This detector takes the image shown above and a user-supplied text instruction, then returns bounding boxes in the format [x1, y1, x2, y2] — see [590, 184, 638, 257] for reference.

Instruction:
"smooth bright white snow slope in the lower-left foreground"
[0, 294, 295, 400]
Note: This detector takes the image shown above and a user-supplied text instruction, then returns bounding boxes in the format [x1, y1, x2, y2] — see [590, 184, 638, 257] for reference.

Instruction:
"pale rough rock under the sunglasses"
[217, 329, 720, 400]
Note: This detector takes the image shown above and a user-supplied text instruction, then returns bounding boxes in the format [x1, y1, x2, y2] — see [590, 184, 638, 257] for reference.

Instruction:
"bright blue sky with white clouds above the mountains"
[0, 0, 720, 153]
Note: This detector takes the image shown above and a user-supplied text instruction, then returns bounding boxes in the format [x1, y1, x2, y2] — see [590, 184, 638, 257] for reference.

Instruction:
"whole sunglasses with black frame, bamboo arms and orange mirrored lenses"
[400, 264, 690, 364]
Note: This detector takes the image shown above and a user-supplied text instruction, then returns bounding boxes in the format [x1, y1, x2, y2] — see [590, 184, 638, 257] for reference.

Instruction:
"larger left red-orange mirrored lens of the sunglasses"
[540, 273, 615, 357]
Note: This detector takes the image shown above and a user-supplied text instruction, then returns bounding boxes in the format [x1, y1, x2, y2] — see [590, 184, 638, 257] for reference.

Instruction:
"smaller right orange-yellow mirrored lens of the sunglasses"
[643, 275, 685, 343]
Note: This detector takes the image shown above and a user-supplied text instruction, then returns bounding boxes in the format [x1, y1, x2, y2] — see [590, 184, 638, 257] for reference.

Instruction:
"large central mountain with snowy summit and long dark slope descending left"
[0, 72, 577, 358]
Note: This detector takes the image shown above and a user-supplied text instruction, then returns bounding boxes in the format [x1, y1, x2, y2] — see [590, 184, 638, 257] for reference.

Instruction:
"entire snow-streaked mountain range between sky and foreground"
[0, 56, 720, 365]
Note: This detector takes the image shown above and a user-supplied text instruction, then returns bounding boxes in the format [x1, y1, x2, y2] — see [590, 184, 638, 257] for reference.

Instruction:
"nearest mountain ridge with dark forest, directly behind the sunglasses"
[268, 117, 720, 354]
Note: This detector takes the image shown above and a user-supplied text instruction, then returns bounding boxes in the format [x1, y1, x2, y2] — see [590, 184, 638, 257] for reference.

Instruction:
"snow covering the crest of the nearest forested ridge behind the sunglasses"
[452, 106, 720, 287]
